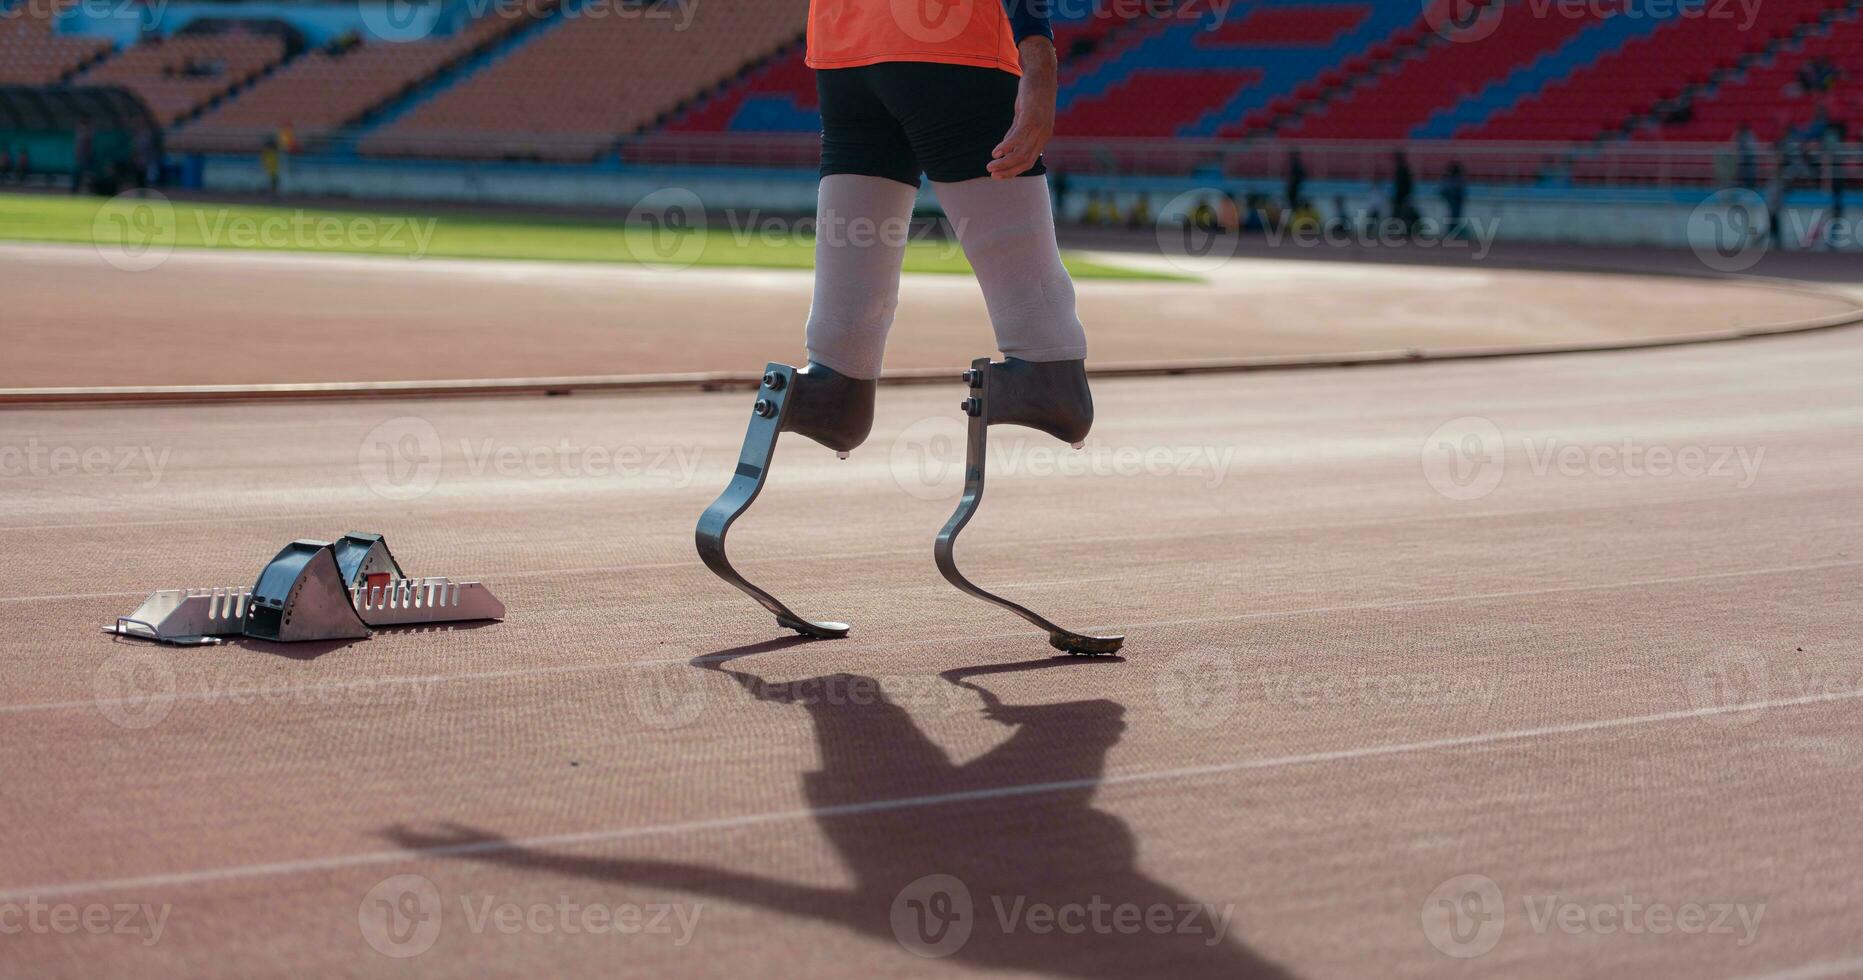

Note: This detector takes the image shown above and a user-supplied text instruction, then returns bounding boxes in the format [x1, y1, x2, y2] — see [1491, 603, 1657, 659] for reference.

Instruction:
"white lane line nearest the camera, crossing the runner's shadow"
[0, 689, 1863, 902]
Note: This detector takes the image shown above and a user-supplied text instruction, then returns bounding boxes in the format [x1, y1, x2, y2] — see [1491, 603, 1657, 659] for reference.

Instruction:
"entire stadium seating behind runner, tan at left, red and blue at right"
[36, 0, 1863, 162]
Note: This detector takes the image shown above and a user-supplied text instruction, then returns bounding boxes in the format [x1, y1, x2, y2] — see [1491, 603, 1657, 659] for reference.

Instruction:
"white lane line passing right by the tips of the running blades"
[0, 559, 1863, 715]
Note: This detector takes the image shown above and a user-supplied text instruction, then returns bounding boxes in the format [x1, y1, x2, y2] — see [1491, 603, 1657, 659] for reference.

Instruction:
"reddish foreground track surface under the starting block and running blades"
[0, 330, 1863, 978]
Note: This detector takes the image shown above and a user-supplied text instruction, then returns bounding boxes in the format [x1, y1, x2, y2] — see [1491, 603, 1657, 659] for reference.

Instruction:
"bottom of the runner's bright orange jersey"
[809, 0, 1023, 75]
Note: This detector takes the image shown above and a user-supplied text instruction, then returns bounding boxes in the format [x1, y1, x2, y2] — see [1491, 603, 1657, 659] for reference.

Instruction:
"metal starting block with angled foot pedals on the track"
[104, 533, 505, 647]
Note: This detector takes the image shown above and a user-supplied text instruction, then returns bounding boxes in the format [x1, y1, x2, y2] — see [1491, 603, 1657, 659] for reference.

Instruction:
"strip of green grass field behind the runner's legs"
[0, 194, 1187, 279]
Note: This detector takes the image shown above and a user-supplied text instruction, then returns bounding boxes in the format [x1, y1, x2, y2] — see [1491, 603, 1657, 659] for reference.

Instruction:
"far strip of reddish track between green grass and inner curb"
[0, 242, 1857, 388]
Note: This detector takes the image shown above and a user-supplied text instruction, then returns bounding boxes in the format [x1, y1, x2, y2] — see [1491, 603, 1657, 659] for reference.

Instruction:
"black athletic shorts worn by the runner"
[816, 61, 1047, 186]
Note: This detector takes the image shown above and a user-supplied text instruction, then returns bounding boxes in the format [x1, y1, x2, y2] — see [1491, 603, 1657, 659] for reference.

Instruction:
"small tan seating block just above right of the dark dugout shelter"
[75, 32, 285, 127]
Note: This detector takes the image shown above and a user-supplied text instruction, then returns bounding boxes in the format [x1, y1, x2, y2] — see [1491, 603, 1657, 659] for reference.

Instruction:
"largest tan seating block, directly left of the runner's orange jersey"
[374, 0, 809, 160]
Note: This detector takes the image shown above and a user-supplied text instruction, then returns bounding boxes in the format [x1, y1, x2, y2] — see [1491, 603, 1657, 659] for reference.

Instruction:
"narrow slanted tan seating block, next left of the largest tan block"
[170, 15, 524, 153]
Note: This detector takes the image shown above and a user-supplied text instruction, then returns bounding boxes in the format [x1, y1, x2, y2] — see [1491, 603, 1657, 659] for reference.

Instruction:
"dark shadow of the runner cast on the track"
[386, 643, 1287, 980]
